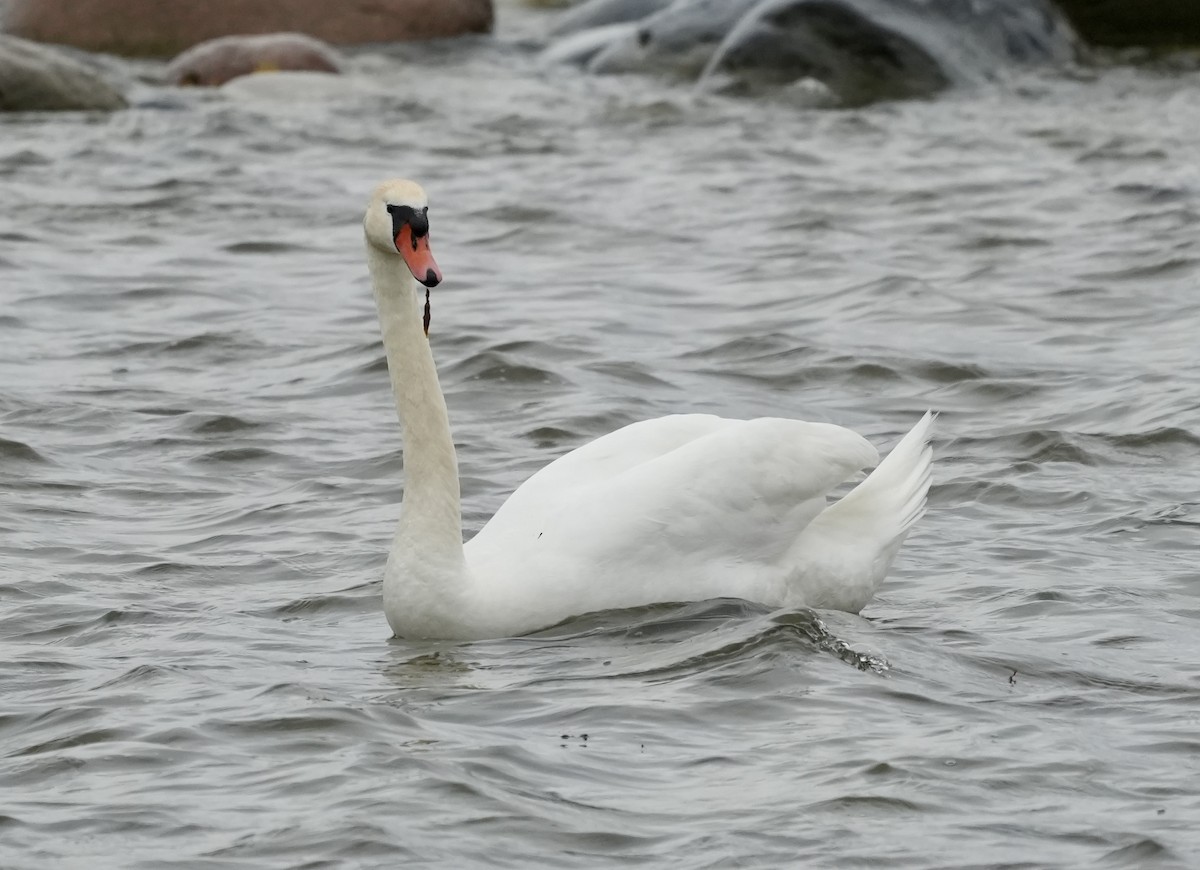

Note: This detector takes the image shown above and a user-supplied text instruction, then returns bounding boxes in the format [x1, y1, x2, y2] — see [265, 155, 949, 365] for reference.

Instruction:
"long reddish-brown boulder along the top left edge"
[5, 0, 492, 56]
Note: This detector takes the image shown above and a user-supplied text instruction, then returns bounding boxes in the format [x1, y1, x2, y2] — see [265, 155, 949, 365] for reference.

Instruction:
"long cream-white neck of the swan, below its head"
[367, 244, 463, 566]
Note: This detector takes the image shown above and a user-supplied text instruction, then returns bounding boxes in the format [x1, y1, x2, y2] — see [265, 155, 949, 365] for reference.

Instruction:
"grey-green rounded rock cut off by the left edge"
[0, 35, 125, 112]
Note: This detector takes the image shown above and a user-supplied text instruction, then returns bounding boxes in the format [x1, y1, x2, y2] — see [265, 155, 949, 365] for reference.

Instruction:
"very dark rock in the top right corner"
[1057, 0, 1200, 48]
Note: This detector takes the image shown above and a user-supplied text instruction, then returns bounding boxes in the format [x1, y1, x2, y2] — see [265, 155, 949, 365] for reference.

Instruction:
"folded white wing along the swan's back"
[467, 415, 878, 608]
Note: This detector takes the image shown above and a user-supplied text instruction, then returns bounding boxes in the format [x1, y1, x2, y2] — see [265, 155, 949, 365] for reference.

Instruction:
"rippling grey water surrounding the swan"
[0, 6, 1200, 870]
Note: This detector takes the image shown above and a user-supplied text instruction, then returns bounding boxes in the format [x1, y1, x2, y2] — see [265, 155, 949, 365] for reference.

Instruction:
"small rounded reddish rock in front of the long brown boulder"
[167, 34, 341, 88]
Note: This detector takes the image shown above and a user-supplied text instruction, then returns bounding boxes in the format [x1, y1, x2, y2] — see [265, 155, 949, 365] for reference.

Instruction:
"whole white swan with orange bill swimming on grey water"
[364, 180, 932, 640]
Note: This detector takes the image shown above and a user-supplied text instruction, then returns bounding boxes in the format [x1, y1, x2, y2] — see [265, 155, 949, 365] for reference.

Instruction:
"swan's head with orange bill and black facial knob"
[362, 179, 442, 287]
